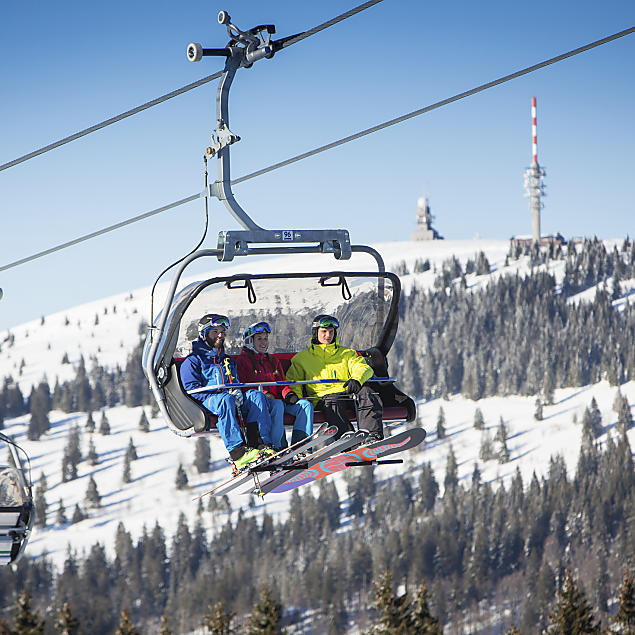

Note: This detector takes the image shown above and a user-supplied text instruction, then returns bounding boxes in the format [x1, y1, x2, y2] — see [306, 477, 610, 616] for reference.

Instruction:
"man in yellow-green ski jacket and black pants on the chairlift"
[286, 315, 384, 441]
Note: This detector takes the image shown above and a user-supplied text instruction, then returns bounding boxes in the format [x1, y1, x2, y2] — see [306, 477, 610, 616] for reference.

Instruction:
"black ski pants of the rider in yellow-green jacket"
[318, 386, 384, 439]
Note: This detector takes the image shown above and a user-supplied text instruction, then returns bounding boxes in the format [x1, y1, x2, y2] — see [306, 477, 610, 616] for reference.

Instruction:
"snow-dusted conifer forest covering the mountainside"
[0, 238, 635, 635]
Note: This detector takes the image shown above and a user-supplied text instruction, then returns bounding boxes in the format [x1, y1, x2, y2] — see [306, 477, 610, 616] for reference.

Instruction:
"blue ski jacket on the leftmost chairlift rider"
[179, 339, 238, 403]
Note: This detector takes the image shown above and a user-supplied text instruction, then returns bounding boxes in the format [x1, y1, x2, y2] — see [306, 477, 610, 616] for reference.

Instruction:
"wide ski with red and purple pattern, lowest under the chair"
[269, 428, 426, 494]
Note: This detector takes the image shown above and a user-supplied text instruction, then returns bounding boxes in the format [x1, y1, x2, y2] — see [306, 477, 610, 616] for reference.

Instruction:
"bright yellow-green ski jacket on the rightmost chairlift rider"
[286, 337, 373, 405]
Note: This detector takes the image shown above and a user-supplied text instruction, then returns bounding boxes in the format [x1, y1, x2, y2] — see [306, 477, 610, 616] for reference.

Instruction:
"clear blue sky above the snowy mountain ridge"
[0, 0, 635, 329]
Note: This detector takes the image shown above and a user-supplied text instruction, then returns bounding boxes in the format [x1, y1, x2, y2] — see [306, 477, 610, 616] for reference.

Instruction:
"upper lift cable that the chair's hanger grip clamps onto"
[0, 0, 383, 172]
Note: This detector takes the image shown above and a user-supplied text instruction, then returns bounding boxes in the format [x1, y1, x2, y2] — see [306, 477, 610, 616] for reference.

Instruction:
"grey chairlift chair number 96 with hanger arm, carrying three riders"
[142, 11, 416, 437]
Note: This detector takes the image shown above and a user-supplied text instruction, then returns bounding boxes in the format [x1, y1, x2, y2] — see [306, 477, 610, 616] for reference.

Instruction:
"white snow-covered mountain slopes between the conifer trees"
[0, 240, 635, 565]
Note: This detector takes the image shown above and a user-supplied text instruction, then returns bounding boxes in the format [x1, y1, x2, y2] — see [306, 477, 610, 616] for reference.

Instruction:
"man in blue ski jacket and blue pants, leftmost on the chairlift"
[179, 313, 273, 469]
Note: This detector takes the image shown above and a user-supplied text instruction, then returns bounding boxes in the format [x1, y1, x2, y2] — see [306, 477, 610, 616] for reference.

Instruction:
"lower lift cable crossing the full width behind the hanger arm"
[0, 27, 635, 272]
